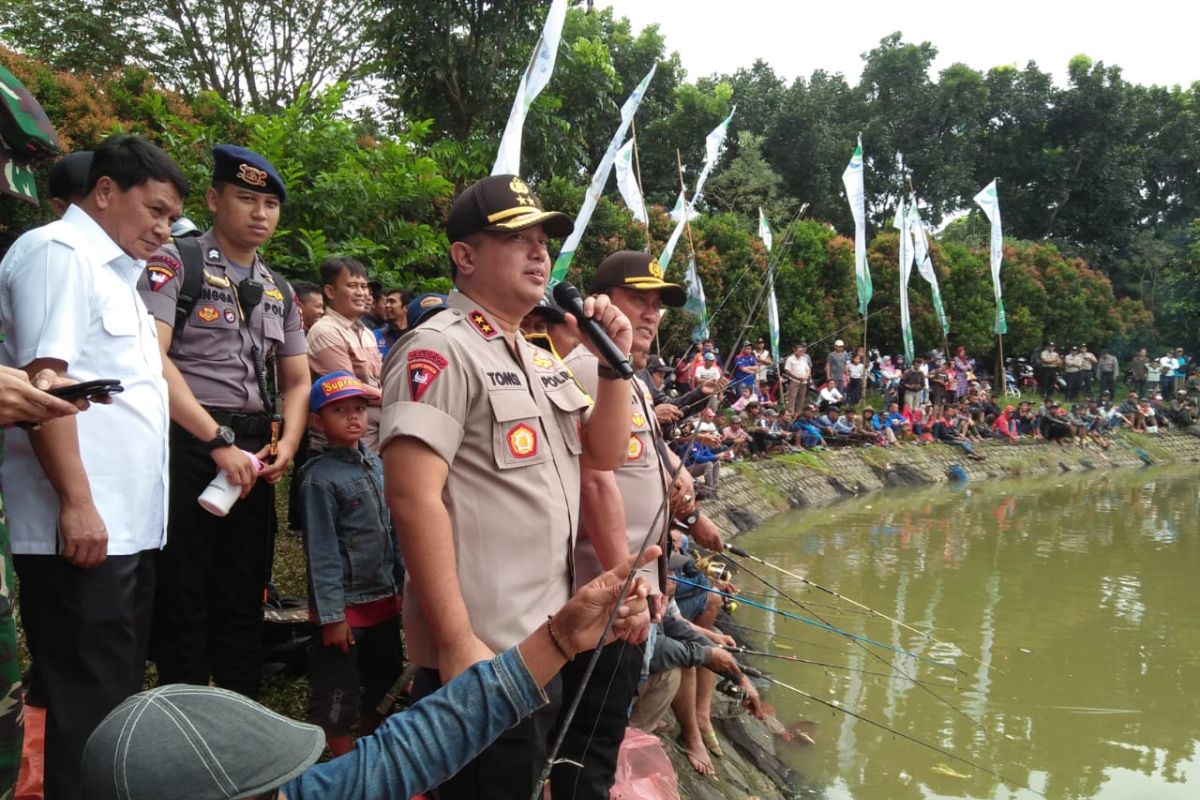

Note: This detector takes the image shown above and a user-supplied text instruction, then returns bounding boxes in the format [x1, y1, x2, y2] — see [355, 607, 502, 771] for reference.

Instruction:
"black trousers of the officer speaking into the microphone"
[413, 667, 563, 800]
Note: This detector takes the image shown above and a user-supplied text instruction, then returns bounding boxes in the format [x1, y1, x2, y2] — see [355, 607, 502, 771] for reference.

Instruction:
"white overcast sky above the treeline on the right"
[595, 0, 1200, 86]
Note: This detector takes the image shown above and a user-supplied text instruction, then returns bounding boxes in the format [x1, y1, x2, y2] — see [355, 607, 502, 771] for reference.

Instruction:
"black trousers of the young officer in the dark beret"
[150, 425, 275, 698]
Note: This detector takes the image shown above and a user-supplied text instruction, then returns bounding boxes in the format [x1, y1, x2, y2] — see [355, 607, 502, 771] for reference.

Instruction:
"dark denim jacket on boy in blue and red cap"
[300, 441, 402, 625]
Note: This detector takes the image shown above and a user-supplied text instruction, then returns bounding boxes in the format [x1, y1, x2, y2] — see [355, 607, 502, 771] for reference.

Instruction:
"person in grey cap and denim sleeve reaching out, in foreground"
[83, 546, 661, 800]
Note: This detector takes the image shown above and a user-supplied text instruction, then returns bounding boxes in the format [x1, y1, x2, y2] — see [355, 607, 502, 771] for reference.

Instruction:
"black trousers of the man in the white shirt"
[12, 551, 155, 800]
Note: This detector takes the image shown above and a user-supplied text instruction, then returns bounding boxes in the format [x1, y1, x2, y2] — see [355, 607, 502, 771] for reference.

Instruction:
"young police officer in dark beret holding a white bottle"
[138, 145, 308, 697]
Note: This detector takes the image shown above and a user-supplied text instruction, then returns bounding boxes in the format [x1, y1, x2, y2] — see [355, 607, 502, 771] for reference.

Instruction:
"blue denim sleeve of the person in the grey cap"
[280, 648, 547, 800]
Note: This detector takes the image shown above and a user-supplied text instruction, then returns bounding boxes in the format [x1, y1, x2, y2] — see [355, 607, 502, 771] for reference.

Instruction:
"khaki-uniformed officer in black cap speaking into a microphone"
[380, 175, 631, 800]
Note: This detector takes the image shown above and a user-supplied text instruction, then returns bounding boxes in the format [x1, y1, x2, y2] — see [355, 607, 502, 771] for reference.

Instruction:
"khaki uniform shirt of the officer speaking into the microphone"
[379, 291, 588, 668]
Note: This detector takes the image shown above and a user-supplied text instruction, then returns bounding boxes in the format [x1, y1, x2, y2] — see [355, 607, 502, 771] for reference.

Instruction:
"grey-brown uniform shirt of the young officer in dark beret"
[138, 230, 307, 414]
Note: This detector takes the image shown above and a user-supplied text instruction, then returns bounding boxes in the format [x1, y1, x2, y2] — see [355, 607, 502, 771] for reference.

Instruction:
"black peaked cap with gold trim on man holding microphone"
[446, 175, 575, 242]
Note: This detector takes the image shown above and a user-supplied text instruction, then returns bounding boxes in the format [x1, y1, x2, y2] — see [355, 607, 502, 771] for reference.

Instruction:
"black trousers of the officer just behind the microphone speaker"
[551, 642, 646, 800]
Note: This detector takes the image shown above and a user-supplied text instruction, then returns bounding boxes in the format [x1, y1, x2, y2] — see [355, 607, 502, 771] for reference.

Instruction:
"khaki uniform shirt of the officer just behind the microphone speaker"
[566, 345, 671, 594]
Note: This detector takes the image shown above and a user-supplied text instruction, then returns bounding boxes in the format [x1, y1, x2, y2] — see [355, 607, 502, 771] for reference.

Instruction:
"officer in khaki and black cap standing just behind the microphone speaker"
[552, 251, 721, 800]
